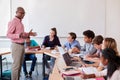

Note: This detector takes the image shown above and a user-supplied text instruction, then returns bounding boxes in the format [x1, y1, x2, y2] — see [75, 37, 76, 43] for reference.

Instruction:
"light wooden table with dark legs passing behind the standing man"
[0, 48, 58, 79]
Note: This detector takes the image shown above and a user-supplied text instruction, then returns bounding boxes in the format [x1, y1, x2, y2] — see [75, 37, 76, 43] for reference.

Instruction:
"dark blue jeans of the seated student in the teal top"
[23, 54, 37, 73]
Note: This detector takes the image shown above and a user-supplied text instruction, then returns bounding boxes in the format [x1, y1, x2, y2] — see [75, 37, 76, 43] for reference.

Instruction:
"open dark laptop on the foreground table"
[63, 53, 82, 67]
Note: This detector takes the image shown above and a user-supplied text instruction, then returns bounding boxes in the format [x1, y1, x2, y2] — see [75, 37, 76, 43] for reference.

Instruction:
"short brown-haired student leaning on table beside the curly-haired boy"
[85, 35, 103, 62]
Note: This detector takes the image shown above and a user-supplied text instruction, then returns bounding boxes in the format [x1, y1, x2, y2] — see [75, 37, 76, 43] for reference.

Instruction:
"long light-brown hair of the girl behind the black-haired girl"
[104, 37, 118, 55]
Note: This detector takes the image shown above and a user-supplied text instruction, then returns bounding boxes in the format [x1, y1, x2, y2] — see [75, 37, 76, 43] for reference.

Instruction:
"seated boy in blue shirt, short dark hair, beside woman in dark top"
[63, 32, 81, 53]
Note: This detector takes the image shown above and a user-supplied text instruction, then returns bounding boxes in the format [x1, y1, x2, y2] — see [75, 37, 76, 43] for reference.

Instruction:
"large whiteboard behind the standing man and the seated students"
[0, 0, 105, 37]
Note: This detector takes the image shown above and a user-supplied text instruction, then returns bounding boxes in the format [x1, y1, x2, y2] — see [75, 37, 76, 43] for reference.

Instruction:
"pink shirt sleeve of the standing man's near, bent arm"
[7, 21, 20, 39]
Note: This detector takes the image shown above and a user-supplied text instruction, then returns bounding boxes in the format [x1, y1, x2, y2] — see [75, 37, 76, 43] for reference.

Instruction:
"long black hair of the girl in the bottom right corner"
[102, 48, 120, 78]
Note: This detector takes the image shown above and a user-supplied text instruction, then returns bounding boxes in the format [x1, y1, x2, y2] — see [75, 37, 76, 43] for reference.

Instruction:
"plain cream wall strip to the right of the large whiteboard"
[106, 0, 120, 51]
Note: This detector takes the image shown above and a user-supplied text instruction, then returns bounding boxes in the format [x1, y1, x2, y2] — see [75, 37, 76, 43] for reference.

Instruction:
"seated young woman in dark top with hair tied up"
[42, 28, 61, 74]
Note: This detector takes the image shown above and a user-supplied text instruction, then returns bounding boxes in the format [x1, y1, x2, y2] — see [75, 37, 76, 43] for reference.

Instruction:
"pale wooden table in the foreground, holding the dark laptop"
[49, 55, 96, 80]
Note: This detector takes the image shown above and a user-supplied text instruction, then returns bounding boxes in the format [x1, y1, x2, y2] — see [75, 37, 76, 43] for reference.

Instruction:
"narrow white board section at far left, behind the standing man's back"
[0, 0, 10, 36]
